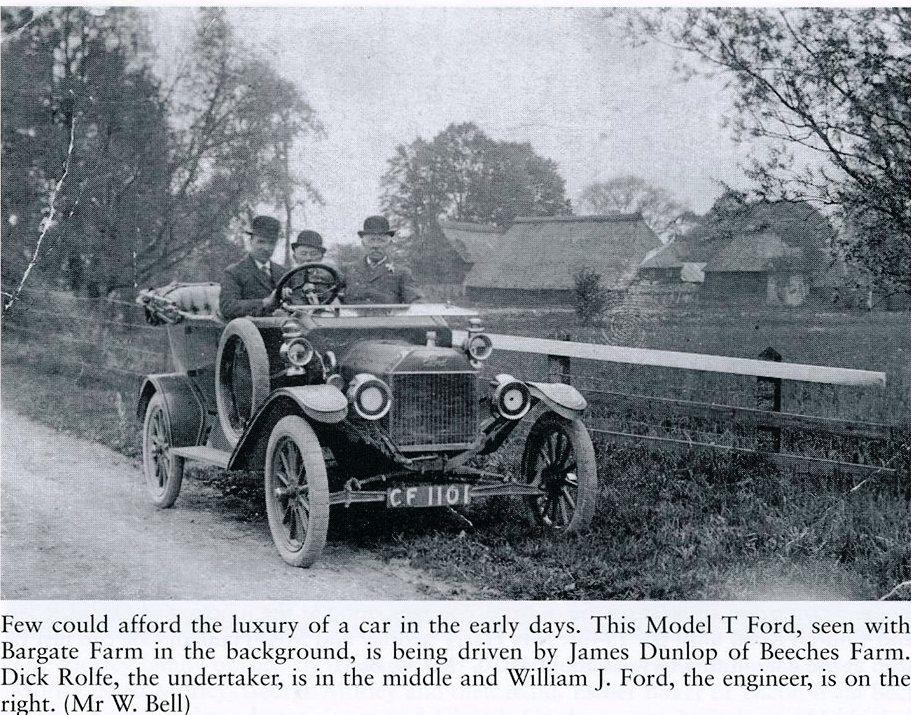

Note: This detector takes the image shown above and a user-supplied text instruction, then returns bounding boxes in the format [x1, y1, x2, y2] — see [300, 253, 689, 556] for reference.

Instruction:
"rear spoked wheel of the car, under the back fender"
[142, 393, 183, 509]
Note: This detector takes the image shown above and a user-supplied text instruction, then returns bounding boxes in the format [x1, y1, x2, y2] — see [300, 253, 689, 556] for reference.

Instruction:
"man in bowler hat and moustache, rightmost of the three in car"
[345, 216, 421, 304]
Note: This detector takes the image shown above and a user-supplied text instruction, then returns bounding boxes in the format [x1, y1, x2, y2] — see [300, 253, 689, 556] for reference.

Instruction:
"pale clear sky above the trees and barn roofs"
[146, 8, 745, 249]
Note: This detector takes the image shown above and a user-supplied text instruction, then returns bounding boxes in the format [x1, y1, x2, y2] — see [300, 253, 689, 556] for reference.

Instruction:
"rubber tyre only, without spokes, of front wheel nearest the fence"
[520, 412, 600, 533]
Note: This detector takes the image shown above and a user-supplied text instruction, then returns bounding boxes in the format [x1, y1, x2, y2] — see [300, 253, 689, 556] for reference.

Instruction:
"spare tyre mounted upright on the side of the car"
[215, 318, 270, 447]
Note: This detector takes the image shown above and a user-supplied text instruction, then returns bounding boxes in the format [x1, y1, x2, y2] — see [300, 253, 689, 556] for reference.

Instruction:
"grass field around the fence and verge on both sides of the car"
[2, 300, 911, 599]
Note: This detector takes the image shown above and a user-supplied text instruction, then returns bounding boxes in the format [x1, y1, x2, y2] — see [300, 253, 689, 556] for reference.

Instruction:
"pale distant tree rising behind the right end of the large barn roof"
[581, 175, 693, 243]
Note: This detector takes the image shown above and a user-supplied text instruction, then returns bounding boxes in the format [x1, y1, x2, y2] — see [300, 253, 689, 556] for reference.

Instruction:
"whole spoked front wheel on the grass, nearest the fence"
[522, 412, 598, 532]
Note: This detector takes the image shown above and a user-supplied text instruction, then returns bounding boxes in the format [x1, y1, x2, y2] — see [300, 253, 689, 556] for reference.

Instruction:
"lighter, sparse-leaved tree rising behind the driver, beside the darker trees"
[155, 8, 321, 284]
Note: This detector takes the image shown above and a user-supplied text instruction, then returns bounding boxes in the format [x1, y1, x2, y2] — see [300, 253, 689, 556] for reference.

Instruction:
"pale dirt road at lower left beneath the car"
[0, 407, 451, 600]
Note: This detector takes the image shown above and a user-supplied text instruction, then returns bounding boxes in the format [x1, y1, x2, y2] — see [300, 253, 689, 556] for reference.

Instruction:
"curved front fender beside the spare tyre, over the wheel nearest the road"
[228, 385, 348, 469]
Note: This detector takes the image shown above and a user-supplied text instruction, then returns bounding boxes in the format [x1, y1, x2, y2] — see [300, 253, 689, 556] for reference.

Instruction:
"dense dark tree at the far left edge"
[3, 8, 168, 296]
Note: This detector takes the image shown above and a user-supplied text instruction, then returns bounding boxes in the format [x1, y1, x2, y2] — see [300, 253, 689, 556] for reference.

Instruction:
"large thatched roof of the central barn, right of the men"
[465, 213, 661, 290]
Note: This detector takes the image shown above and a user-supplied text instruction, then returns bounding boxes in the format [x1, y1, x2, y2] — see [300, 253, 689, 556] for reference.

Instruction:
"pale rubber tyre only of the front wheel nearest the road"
[264, 415, 329, 568]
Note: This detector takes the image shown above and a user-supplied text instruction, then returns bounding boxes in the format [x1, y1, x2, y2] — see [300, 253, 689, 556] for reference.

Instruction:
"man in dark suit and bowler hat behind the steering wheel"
[219, 216, 285, 320]
